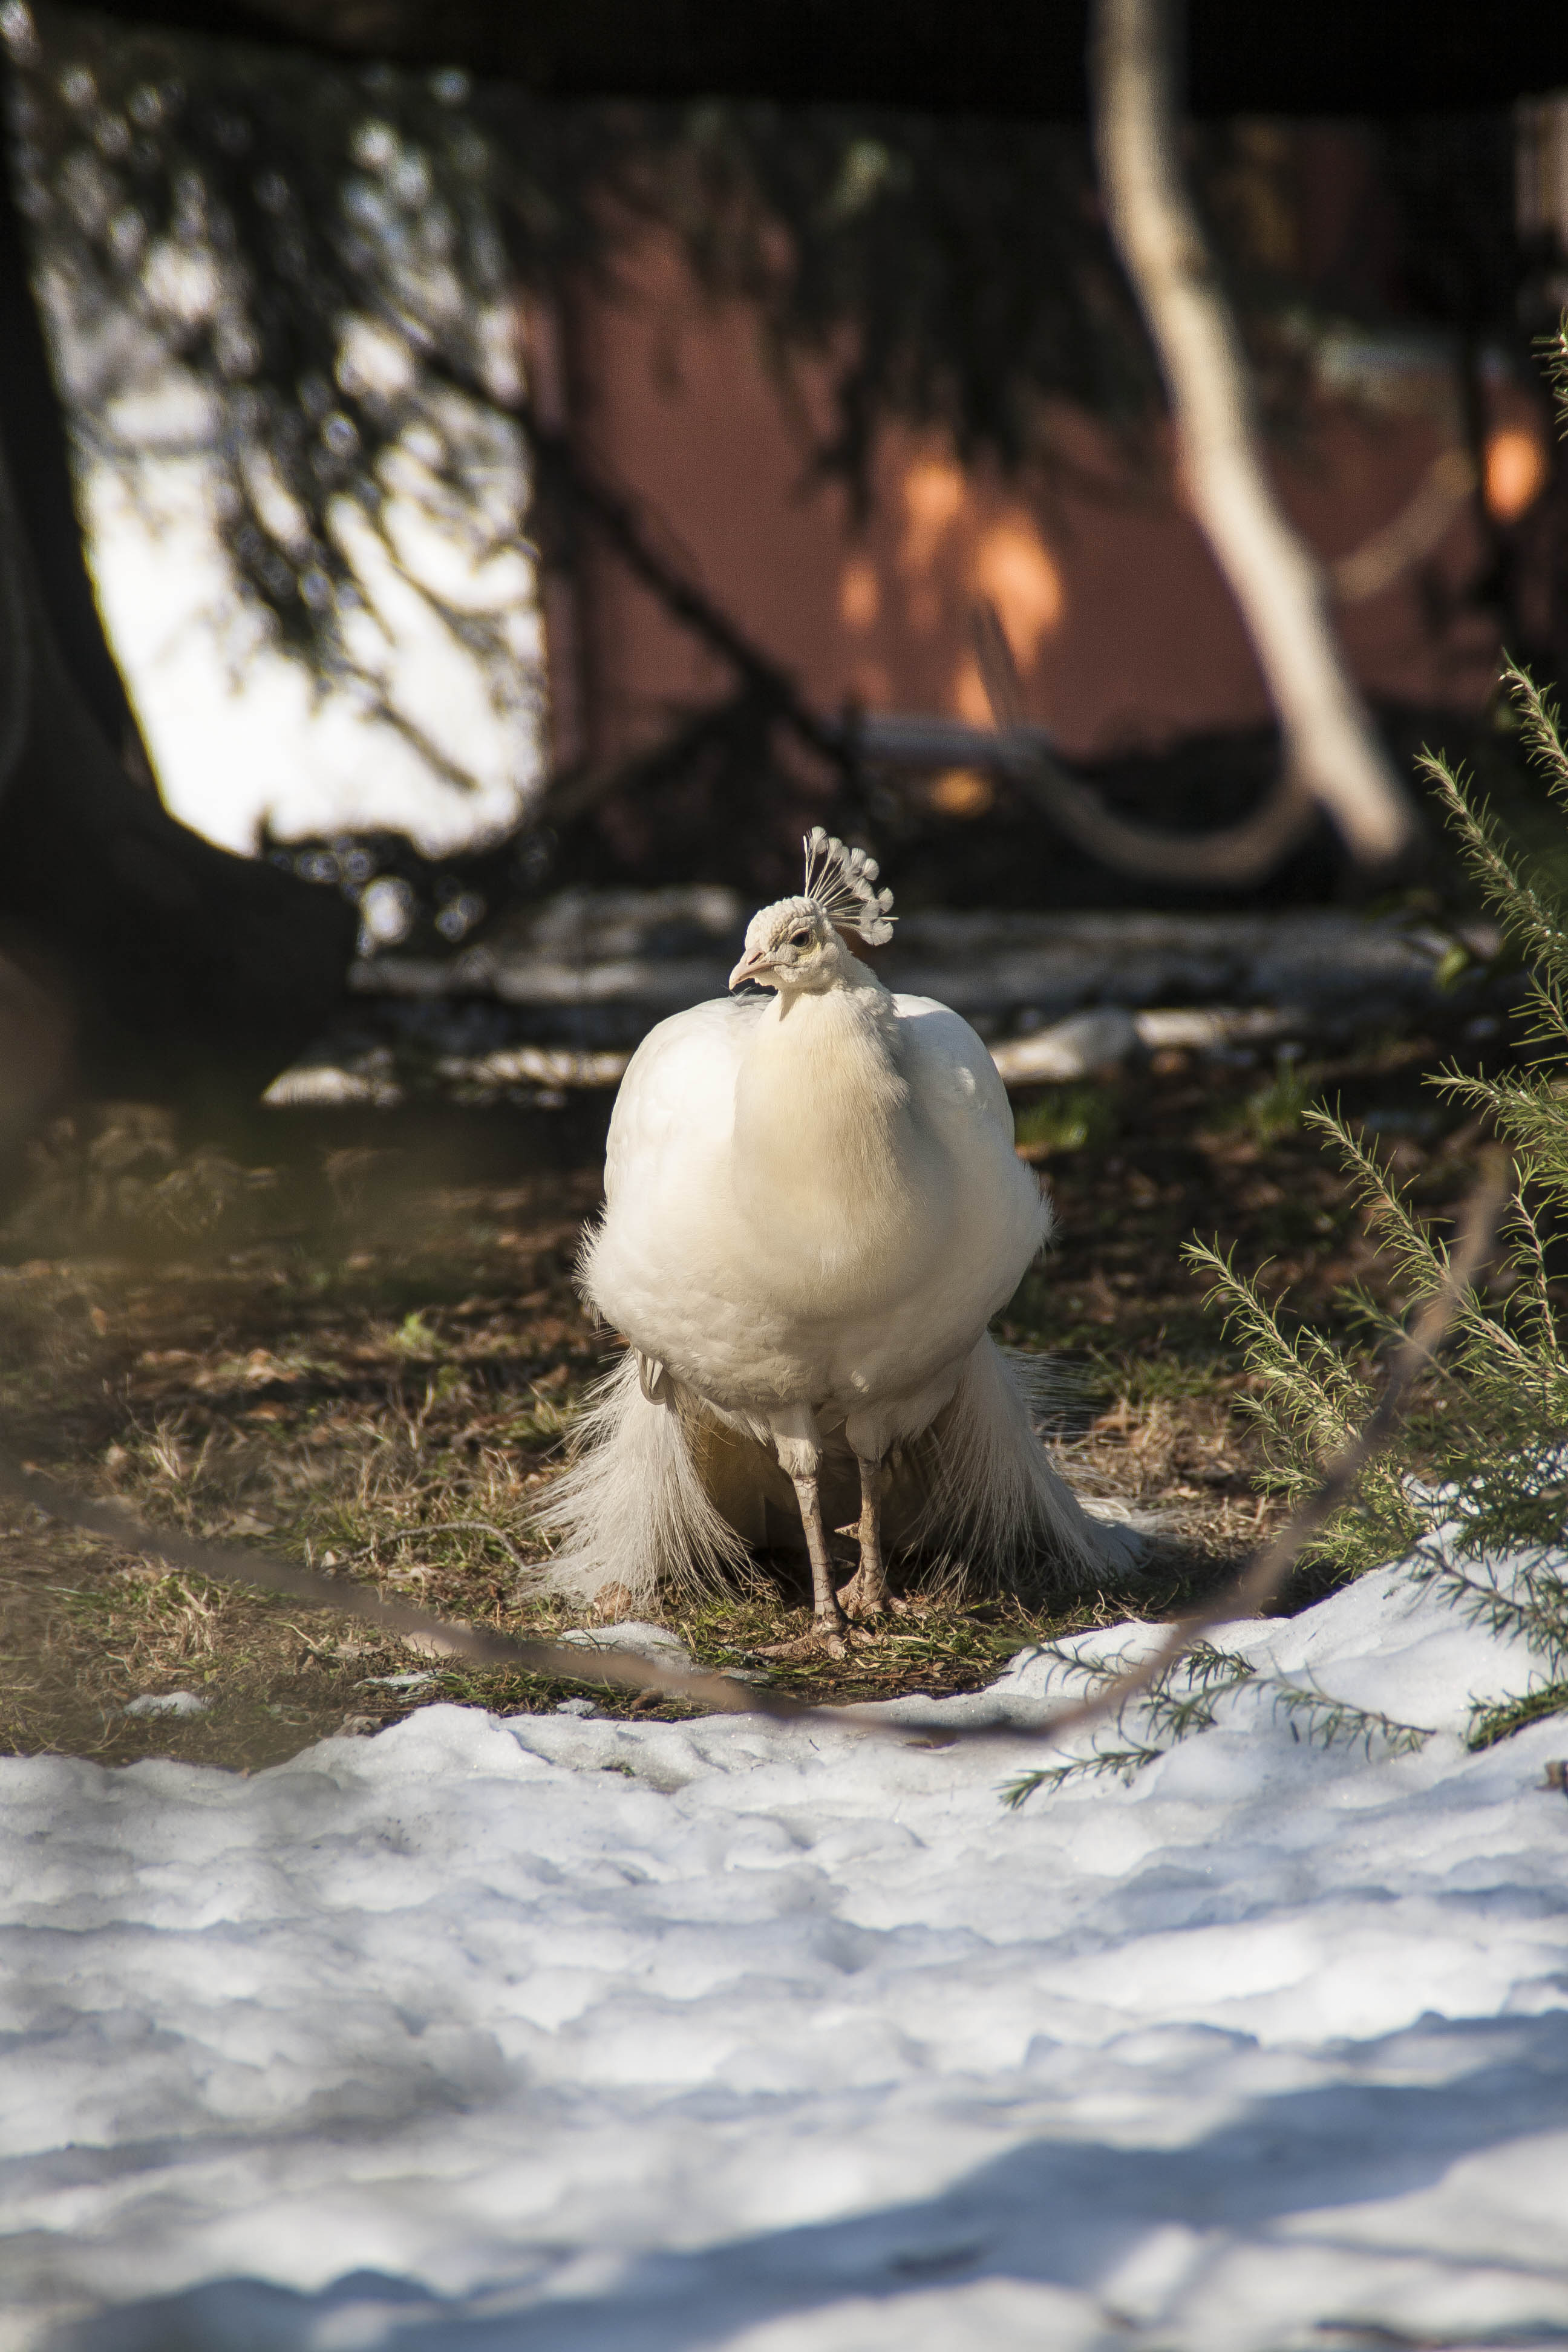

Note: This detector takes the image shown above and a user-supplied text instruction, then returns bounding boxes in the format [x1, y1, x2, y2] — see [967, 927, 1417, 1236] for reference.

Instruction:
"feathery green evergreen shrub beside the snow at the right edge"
[1189, 477, 1568, 1743]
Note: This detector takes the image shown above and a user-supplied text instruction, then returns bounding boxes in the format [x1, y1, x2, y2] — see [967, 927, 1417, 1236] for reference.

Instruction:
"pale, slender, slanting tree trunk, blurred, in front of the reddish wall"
[1091, 0, 1415, 866]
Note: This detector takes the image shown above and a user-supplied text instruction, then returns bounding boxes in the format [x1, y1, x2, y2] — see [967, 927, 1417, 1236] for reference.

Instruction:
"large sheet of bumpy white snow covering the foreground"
[0, 1571, 1568, 2352]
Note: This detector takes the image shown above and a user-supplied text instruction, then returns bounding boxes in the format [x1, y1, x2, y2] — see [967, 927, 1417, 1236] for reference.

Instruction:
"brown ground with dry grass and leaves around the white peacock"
[0, 1035, 1495, 1769]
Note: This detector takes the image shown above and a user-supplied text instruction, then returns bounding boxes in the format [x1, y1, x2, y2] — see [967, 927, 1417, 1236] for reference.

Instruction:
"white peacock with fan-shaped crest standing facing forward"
[547, 830, 1123, 1647]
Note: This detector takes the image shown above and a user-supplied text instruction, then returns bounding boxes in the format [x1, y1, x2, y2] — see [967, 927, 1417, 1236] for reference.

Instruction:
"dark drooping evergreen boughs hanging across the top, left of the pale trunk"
[0, 0, 1157, 734]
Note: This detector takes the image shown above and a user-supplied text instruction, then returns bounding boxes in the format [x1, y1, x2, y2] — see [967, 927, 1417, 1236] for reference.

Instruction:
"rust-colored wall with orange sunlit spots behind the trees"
[571, 238, 1540, 757]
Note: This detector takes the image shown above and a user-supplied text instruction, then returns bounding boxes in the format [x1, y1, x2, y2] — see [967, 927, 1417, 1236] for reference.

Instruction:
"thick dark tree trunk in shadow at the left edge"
[0, 133, 355, 1105]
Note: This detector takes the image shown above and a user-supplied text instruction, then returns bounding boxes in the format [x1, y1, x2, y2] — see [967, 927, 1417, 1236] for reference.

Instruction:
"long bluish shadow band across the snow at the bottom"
[47, 2011, 1568, 2352]
